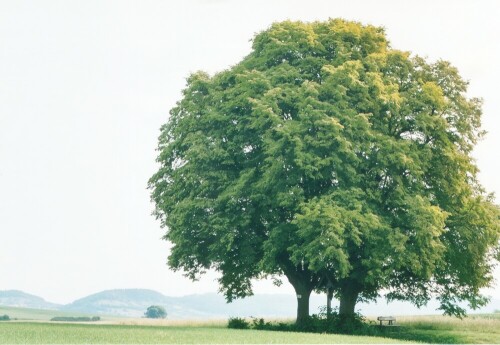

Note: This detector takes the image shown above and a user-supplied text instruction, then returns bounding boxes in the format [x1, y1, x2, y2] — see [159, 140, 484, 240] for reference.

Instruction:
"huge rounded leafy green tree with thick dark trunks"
[149, 19, 500, 323]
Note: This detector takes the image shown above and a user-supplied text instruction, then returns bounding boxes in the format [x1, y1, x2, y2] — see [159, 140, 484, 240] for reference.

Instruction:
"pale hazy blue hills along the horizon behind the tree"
[0, 289, 500, 319]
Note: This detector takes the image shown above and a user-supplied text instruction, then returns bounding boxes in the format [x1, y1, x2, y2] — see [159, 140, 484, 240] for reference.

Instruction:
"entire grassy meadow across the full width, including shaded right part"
[0, 307, 500, 344]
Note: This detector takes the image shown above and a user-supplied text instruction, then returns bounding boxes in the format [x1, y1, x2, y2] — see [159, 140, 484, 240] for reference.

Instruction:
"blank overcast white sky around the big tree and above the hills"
[0, 0, 500, 303]
